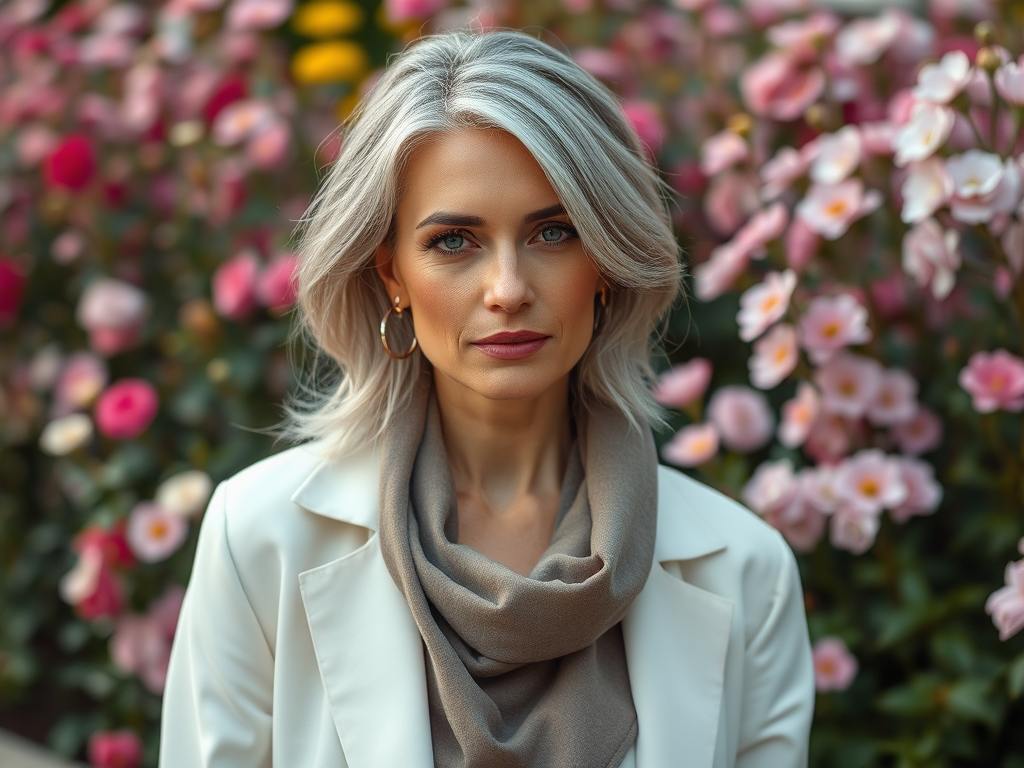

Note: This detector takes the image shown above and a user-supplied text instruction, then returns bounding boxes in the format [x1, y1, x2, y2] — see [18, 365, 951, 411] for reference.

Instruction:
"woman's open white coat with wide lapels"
[160, 436, 814, 768]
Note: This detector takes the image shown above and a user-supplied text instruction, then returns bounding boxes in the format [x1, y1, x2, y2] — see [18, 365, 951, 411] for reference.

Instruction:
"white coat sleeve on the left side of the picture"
[160, 482, 273, 768]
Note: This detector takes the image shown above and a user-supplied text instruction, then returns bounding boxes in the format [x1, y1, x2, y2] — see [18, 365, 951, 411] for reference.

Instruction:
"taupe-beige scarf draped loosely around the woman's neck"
[380, 373, 657, 768]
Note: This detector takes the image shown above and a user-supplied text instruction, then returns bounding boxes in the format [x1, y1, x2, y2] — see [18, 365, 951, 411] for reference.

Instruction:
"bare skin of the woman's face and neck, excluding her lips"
[375, 128, 606, 575]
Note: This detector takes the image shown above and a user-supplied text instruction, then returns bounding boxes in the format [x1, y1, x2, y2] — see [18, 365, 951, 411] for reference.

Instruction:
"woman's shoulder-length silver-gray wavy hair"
[276, 29, 682, 456]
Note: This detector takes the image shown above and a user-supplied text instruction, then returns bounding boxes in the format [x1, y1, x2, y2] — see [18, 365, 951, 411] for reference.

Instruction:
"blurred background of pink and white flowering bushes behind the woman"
[0, 0, 1024, 768]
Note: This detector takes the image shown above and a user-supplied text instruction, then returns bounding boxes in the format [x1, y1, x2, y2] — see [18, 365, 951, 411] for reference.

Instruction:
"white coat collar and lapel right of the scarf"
[623, 469, 733, 768]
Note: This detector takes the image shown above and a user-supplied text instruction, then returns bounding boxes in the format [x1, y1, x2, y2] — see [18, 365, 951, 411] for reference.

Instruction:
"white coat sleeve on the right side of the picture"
[736, 531, 814, 768]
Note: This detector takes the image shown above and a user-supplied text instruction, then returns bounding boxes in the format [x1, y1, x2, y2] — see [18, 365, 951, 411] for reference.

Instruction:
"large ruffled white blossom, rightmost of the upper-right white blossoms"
[946, 150, 1021, 224]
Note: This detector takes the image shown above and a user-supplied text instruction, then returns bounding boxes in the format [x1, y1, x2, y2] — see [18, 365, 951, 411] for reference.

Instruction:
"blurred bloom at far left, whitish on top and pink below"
[76, 278, 150, 356]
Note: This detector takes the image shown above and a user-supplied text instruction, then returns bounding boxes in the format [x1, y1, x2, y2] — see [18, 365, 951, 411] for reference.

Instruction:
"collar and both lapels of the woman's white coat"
[291, 438, 733, 768]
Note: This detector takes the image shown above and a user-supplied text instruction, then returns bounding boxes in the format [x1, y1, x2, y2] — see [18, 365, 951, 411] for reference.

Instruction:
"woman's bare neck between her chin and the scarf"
[434, 370, 572, 513]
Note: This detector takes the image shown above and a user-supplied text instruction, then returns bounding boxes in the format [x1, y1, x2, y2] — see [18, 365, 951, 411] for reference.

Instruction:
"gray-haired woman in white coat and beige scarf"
[161, 31, 813, 768]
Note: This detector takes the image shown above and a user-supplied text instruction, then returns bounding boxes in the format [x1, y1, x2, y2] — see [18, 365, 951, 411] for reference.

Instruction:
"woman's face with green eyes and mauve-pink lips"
[377, 128, 605, 400]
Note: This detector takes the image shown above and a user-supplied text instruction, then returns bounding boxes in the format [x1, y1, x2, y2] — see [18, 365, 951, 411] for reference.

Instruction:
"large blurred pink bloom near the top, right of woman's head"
[739, 51, 825, 121]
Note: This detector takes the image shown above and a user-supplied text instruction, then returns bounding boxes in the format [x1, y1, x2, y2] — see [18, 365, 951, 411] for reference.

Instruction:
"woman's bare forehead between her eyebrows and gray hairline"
[399, 128, 558, 214]
